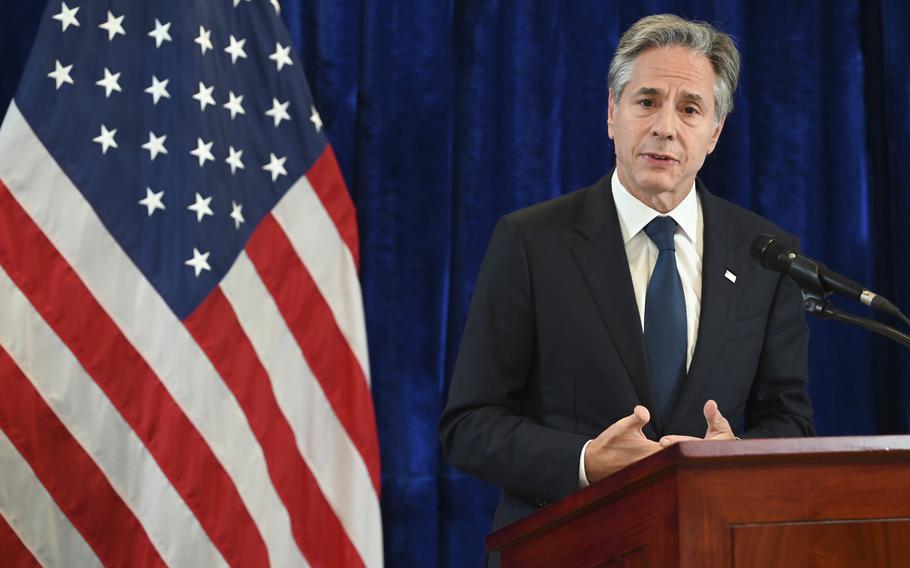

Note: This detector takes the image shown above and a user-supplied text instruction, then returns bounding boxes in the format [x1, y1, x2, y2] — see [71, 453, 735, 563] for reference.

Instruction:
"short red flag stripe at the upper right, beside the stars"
[306, 145, 360, 266]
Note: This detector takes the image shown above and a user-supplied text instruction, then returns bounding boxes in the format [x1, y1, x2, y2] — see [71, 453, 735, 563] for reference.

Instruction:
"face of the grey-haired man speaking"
[607, 47, 724, 213]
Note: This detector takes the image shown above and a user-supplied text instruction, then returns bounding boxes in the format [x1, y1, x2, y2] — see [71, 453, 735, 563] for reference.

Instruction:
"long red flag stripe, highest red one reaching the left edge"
[0, 183, 268, 566]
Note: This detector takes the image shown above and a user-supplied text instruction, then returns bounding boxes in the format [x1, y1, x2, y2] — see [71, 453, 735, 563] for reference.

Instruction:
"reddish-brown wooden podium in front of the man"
[487, 436, 910, 568]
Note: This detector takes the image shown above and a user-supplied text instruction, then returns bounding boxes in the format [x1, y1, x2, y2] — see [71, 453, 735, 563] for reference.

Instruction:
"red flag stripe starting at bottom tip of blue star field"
[184, 288, 363, 566]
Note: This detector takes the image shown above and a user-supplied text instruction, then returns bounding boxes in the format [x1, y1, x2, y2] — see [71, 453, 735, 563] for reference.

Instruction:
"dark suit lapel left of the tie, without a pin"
[572, 176, 659, 438]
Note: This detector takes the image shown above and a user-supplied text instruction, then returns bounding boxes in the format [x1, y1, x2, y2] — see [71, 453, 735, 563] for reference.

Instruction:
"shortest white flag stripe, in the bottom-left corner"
[0, 428, 101, 568]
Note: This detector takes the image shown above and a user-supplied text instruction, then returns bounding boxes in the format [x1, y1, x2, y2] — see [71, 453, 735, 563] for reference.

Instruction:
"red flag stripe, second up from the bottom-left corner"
[0, 348, 165, 566]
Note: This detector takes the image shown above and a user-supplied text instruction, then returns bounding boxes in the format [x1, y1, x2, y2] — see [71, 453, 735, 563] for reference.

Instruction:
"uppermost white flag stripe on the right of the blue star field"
[272, 177, 370, 383]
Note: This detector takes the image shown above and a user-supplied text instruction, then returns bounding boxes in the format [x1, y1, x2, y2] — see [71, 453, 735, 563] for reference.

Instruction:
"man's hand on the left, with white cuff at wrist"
[584, 405, 660, 483]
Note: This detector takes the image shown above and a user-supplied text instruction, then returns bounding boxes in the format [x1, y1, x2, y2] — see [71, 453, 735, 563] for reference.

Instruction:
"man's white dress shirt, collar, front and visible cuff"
[578, 170, 705, 487]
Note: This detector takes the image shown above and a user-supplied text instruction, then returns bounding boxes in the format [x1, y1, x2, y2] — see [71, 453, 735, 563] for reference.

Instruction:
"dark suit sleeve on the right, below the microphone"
[741, 235, 815, 438]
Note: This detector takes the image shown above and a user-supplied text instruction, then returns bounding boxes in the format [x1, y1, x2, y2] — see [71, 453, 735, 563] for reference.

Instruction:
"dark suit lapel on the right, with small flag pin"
[666, 182, 749, 434]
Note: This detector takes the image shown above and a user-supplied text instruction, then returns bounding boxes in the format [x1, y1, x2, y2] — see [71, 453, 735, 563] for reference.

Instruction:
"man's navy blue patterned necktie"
[645, 217, 688, 428]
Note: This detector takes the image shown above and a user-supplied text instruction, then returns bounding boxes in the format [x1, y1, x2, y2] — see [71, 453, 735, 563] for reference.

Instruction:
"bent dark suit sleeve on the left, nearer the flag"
[439, 217, 587, 504]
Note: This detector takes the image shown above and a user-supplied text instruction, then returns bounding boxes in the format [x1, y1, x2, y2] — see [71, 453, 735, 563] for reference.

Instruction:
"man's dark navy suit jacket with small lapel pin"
[440, 176, 814, 540]
